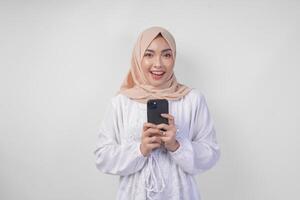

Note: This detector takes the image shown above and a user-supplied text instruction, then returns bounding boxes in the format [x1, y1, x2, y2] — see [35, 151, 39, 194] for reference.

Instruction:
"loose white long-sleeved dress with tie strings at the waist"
[94, 89, 220, 200]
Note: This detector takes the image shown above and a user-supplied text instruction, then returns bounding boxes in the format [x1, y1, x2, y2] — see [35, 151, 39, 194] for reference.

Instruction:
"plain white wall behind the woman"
[0, 0, 300, 200]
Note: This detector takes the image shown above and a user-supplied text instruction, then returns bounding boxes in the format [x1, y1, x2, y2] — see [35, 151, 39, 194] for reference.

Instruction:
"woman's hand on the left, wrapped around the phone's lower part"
[140, 122, 162, 156]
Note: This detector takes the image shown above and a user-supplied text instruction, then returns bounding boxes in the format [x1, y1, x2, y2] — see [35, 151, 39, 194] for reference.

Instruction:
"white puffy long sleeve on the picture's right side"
[169, 93, 220, 174]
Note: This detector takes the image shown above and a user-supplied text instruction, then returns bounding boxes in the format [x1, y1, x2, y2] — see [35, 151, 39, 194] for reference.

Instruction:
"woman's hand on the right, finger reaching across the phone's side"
[157, 113, 180, 151]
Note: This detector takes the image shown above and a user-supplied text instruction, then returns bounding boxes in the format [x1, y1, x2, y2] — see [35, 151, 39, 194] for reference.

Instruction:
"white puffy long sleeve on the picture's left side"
[94, 99, 146, 176]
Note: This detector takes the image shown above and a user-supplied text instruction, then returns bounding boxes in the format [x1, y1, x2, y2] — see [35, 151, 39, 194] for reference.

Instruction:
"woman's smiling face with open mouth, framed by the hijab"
[141, 36, 174, 88]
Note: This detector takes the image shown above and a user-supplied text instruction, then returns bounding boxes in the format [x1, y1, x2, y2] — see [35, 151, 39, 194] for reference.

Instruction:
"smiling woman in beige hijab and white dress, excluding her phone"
[94, 27, 220, 200]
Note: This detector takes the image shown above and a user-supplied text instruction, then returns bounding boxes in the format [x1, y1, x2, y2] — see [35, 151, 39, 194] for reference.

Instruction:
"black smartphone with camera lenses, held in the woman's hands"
[147, 99, 169, 124]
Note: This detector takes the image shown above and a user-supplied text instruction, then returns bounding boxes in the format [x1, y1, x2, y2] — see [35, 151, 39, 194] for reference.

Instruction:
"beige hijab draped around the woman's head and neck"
[118, 27, 191, 103]
